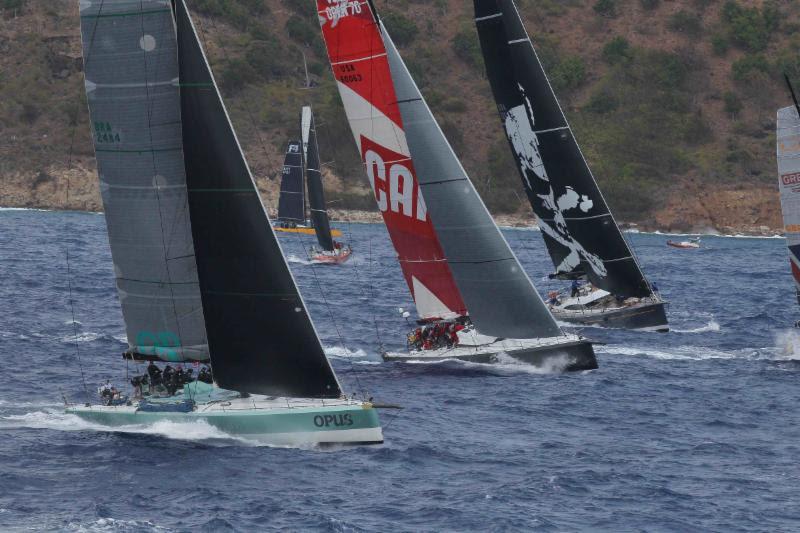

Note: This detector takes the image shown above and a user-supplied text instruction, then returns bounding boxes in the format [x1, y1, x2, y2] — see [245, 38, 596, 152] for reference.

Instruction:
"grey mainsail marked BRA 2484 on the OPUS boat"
[80, 0, 209, 361]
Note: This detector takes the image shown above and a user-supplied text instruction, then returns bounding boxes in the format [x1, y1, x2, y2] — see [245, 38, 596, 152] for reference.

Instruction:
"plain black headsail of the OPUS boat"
[173, 0, 341, 398]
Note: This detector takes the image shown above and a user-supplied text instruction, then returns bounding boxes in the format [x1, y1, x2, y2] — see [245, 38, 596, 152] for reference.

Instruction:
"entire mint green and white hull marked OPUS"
[66, 404, 383, 444]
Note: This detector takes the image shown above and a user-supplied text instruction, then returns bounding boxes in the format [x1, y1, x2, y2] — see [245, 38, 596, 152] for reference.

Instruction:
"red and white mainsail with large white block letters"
[317, 0, 466, 319]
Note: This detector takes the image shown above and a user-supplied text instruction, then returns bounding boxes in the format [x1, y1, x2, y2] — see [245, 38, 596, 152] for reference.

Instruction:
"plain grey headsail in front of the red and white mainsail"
[381, 25, 563, 339]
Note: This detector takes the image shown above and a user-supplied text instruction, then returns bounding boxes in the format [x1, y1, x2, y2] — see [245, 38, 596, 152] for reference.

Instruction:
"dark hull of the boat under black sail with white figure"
[551, 302, 669, 333]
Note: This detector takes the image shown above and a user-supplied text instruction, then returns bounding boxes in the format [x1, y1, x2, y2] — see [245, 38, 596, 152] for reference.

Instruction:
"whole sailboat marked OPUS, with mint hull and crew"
[67, 0, 383, 444]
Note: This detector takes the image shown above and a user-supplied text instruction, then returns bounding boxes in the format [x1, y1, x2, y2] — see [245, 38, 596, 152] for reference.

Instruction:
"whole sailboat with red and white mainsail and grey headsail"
[317, 0, 597, 370]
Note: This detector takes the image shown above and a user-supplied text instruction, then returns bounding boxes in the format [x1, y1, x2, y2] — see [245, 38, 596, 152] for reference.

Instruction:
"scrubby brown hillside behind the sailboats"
[0, 0, 800, 231]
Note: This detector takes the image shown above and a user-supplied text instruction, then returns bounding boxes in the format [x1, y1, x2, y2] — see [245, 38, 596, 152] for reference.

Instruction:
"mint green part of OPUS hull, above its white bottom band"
[67, 406, 380, 436]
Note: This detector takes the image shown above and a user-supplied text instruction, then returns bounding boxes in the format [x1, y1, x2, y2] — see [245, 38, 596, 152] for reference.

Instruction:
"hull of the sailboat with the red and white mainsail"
[383, 340, 598, 372]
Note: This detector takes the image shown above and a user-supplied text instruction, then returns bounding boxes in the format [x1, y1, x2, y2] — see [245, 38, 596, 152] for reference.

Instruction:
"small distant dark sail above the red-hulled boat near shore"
[301, 107, 333, 252]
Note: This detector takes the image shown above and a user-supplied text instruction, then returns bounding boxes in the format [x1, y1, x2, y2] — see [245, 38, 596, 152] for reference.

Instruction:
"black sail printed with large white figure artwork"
[474, 0, 652, 297]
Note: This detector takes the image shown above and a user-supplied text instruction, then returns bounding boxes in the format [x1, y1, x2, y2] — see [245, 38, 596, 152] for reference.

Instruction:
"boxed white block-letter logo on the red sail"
[364, 144, 428, 222]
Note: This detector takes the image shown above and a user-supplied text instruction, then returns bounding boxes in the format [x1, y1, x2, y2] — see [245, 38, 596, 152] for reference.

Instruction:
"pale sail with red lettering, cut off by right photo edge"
[777, 106, 800, 304]
